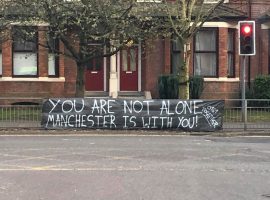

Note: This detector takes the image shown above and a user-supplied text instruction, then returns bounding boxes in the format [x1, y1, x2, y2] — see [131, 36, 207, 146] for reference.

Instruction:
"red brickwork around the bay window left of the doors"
[0, 27, 76, 98]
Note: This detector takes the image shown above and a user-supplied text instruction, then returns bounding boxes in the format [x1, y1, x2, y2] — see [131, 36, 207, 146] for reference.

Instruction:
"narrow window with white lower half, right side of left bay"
[48, 37, 59, 77]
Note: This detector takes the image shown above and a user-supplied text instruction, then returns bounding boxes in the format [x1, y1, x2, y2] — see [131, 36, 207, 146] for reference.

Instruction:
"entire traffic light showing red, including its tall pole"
[238, 21, 256, 131]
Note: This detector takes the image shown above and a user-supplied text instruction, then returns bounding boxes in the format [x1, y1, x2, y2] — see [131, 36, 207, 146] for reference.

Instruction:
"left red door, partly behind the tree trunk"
[85, 57, 104, 91]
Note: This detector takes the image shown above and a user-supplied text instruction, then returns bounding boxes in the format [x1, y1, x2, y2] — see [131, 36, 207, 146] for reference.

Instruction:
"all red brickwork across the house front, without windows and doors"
[0, 3, 270, 99]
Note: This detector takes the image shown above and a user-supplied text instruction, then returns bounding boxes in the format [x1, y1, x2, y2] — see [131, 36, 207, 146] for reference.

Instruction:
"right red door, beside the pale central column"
[120, 46, 138, 91]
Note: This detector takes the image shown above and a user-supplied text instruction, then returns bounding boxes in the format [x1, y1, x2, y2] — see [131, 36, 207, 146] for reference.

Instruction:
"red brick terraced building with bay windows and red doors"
[0, 0, 270, 99]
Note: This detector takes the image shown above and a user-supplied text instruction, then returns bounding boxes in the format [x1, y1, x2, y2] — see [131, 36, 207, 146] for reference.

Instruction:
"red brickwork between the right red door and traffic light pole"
[142, 28, 243, 99]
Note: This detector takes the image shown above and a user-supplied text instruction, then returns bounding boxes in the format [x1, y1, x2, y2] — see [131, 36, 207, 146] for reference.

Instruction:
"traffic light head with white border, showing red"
[238, 21, 256, 56]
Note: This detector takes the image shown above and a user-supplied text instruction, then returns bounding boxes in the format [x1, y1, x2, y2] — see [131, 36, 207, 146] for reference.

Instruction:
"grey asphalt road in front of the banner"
[0, 135, 270, 200]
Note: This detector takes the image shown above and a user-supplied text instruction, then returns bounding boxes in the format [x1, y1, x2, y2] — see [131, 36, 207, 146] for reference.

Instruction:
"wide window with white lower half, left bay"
[13, 27, 38, 76]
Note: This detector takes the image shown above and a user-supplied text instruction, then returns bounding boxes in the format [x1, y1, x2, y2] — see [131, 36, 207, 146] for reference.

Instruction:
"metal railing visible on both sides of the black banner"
[0, 99, 270, 131]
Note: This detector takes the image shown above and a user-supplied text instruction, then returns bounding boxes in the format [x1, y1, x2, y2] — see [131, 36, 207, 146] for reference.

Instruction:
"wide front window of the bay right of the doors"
[194, 29, 218, 77]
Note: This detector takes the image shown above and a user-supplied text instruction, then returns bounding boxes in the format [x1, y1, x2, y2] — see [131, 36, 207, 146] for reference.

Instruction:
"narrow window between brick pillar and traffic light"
[227, 29, 235, 77]
